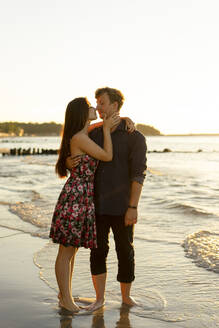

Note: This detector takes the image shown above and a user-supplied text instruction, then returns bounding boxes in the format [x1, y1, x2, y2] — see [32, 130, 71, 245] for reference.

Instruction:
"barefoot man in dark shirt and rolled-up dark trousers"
[69, 87, 147, 311]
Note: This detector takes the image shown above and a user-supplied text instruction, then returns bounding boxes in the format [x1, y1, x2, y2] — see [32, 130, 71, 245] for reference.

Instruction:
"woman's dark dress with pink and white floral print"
[49, 154, 98, 248]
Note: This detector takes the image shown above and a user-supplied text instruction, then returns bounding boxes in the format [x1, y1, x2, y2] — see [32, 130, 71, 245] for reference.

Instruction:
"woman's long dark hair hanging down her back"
[55, 97, 90, 178]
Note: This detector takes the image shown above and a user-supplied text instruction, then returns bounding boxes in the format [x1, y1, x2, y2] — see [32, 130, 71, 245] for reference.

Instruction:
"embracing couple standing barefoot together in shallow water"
[50, 87, 147, 312]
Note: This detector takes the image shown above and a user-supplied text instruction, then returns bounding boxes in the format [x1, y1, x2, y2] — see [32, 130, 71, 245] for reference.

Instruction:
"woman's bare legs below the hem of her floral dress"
[55, 245, 79, 312]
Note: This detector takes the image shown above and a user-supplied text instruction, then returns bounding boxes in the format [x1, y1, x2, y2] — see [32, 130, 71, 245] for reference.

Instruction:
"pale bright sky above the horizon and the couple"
[0, 0, 219, 134]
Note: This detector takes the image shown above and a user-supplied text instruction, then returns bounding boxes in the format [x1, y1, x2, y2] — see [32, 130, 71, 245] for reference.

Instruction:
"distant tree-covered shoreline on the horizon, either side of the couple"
[0, 122, 161, 136]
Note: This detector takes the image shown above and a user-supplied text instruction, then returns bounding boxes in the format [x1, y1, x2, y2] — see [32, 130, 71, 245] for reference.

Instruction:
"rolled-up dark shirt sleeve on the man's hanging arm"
[129, 131, 147, 185]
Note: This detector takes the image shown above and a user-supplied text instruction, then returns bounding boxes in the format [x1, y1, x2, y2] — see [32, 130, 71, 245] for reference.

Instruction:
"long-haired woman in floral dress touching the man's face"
[50, 98, 119, 312]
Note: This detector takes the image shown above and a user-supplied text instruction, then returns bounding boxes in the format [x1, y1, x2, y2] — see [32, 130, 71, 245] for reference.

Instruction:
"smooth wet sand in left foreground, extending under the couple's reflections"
[0, 228, 180, 328]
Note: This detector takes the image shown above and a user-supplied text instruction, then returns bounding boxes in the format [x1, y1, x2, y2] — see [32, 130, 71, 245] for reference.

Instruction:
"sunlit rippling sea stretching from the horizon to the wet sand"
[0, 136, 219, 328]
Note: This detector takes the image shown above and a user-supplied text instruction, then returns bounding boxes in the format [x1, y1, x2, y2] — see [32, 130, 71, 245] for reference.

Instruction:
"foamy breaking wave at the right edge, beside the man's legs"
[182, 231, 219, 273]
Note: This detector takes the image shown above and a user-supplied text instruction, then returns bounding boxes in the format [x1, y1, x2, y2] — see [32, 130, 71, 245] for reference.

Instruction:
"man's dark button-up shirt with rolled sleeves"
[89, 120, 147, 215]
